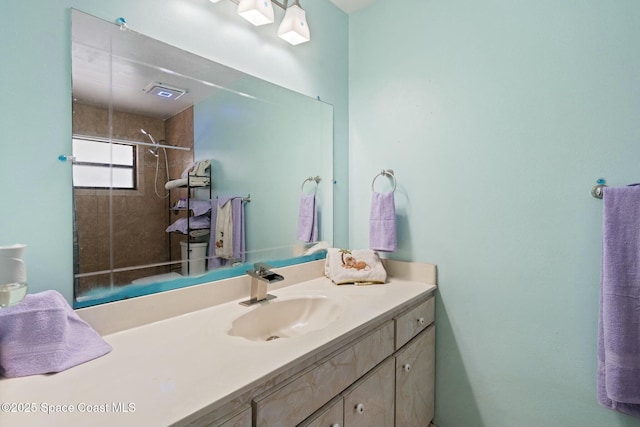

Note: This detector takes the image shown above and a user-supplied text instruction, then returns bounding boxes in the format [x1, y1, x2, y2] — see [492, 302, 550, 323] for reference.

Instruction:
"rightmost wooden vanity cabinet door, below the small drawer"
[395, 325, 436, 427]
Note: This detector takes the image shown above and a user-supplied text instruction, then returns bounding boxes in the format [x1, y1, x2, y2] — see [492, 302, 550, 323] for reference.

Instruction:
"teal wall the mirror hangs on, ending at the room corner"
[0, 0, 348, 301]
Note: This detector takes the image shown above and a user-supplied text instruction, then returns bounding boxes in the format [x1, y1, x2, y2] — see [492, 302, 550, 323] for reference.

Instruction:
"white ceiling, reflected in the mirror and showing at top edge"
[72, 0, 375, 119]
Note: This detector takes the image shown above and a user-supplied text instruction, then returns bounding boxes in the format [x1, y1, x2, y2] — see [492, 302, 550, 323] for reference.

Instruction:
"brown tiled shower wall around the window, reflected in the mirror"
[73, 104, 193, 295]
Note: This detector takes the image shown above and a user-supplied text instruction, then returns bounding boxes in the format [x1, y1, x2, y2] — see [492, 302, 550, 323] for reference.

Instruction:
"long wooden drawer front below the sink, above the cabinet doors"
[253, 322, 394, 427]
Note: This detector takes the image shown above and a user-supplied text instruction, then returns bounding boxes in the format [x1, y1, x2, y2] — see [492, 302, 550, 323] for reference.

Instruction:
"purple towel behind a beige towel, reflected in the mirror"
[207, 197, 247, 270]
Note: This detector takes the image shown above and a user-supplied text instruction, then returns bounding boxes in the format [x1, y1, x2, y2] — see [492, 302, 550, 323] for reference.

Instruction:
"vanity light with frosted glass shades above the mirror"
[209, 0, 311, 46]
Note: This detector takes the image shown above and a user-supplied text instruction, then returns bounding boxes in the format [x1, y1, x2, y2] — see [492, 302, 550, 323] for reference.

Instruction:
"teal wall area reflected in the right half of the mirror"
[193, 78, 333, 254]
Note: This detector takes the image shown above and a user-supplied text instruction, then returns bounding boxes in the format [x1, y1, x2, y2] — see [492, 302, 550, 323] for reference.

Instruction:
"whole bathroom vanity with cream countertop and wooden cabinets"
[0, 260, 436, 427]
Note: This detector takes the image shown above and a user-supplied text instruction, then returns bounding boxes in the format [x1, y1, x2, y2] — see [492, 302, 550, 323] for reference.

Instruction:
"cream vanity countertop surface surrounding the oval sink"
[0, 263, 435, 426]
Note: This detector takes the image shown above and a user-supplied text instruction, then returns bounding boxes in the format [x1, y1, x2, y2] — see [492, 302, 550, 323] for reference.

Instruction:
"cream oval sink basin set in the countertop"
[228, 295, 342, 341]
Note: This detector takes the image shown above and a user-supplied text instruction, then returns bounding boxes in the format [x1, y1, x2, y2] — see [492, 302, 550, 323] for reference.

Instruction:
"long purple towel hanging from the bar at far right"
[598, 187, 640, 417]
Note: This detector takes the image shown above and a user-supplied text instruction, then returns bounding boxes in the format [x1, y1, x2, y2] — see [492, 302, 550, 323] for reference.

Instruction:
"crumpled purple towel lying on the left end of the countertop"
[0, 291, 111, 378]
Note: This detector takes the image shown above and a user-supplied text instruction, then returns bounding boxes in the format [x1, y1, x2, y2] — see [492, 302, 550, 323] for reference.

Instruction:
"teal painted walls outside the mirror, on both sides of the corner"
[5, 0, 640, 427]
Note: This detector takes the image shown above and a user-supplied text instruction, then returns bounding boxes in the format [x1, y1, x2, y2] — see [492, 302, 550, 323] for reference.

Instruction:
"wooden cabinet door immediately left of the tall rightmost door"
[343, 358, 395, 427]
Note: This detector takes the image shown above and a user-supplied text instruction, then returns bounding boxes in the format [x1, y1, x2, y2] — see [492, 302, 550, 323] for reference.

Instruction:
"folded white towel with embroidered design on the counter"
[324, 248, 387, 285]
